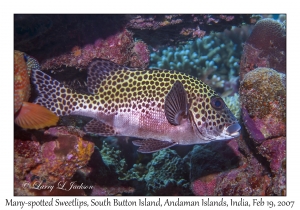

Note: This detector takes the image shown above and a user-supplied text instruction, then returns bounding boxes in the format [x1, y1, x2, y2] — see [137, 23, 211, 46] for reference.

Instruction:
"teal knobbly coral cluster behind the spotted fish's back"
[150, 33, 239, 80]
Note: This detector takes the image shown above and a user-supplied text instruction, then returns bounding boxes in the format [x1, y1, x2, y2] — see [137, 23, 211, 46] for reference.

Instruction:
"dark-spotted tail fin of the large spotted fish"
[31, 70, 82, 116]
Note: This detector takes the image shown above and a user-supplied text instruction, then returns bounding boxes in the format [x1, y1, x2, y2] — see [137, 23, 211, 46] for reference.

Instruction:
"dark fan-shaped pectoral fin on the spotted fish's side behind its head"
[165, 81, 188, 125]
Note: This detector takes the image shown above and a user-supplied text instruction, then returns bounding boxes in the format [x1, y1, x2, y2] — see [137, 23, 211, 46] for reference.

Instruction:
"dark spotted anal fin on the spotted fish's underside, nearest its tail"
[84, 119, 117, 136]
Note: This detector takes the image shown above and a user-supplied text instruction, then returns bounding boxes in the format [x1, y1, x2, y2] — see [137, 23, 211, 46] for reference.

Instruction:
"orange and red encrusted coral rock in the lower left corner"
[14, 127, 94, 195]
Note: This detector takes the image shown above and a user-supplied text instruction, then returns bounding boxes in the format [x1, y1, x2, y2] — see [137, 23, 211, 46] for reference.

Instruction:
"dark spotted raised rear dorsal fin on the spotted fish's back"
[87, 59, 130, 94]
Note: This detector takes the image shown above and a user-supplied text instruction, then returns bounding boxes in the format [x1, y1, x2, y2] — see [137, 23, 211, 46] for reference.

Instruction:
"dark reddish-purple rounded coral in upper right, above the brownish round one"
[240, 18, 286, 80]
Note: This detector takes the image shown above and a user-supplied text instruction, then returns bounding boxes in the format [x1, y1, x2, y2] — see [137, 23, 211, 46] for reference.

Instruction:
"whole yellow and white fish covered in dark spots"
[32, 59, 241, 153]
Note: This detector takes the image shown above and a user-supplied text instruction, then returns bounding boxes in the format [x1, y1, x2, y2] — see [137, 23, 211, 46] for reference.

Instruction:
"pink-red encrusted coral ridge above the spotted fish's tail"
[41, 30, 149, 69]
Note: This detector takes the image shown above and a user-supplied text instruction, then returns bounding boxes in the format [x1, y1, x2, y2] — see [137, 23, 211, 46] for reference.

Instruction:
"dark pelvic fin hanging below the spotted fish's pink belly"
[132, 139, 177, 153]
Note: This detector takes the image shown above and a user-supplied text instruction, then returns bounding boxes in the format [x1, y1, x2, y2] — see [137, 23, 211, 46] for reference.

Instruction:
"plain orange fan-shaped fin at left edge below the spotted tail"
[15, 102, 59, 129]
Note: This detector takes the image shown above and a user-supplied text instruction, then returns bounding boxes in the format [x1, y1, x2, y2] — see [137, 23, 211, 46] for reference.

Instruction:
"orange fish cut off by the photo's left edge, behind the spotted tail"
[14, 50, 59, 129]
